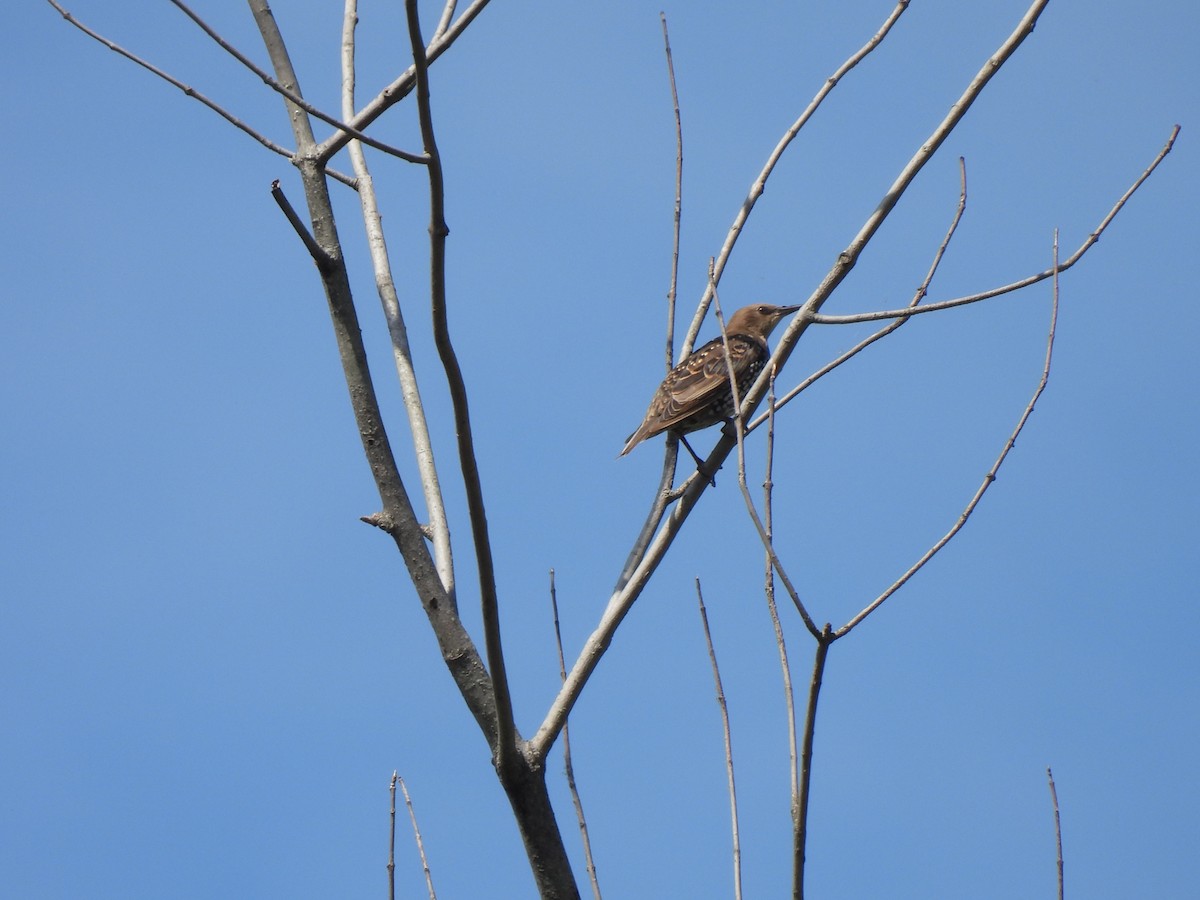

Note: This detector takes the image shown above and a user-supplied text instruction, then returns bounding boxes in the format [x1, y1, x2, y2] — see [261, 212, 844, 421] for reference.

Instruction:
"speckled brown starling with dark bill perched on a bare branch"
[620, 304, 800, 464]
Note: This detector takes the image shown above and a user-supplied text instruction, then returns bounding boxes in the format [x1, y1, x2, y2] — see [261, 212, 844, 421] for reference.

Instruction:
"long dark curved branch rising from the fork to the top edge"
[404, 0, 516, 763]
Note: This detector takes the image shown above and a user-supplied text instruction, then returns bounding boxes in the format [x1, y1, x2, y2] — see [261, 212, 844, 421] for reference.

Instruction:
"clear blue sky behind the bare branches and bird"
[0, 0, 1200, 898]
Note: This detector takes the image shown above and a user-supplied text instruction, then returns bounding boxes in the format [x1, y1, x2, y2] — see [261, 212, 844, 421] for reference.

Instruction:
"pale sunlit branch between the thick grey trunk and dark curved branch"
[342, 0, 456, 605]
